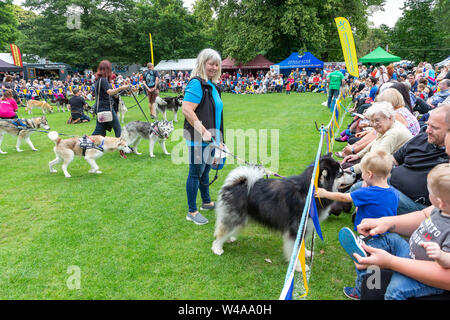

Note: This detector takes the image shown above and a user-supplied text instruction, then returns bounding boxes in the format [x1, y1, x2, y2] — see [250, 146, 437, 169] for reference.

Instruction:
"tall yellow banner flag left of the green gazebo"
[334, 17, 359, 78]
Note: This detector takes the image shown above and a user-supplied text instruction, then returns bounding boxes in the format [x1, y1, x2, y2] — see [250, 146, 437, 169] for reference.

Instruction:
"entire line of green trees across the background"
[7, 0, 450, 67]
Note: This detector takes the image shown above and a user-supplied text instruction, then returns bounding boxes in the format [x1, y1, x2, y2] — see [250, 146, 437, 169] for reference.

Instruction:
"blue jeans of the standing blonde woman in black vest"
[186, 146, 215, 212]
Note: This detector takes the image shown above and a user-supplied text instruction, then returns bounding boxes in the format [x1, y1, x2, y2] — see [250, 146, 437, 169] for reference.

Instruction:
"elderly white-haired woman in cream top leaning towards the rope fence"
[342, 102, 413, 173]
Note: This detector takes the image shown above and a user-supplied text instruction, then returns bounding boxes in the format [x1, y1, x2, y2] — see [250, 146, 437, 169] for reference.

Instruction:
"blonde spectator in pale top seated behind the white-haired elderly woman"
[375, 88, 420, 136]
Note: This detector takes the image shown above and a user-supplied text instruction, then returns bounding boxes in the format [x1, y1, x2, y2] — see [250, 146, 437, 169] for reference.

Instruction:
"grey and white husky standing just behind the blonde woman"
[121, 120, 174, 158]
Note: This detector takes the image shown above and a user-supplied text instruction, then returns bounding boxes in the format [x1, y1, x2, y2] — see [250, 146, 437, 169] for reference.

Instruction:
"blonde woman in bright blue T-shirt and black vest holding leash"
[182, 49, 223, 225]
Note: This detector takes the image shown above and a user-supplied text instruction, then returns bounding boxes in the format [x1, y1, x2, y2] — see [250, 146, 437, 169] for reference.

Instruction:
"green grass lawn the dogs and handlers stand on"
[0, 93, 354, 300]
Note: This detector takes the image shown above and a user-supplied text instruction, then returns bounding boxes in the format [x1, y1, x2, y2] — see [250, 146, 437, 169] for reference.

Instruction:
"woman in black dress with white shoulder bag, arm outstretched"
[92, 60, 129, 138]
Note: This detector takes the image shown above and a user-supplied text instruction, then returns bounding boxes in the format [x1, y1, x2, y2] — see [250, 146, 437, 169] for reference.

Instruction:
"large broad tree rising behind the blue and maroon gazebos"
[197, 0, 384, 62]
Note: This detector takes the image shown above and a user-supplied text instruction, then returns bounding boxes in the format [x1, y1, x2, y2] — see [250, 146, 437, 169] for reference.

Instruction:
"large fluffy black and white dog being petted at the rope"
[212, 155, 355, 269]
